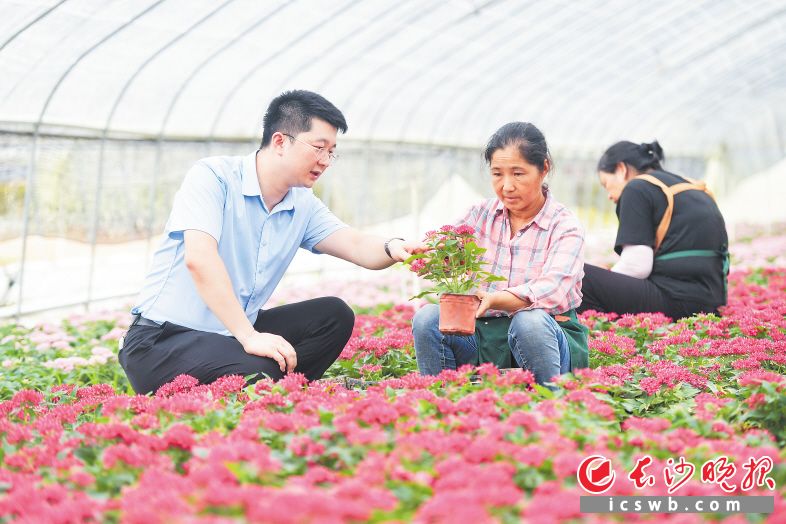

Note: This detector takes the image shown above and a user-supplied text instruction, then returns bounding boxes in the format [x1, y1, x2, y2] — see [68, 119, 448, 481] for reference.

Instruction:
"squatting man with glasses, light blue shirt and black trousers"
[119, 91, 421, 393]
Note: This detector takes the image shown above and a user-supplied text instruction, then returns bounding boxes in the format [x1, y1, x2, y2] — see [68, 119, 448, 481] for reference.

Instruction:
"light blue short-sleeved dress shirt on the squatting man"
[131, 152, 347, 336]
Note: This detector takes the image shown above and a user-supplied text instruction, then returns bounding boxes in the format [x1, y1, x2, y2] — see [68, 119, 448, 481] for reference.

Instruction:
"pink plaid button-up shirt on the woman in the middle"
[456, 192, 584, 316]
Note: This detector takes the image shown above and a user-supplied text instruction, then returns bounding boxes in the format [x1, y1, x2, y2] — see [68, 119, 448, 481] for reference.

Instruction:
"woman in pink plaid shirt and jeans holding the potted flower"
[412, 122, 584, 384]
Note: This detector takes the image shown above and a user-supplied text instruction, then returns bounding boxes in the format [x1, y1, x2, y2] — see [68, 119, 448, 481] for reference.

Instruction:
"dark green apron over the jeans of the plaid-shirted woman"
[475, 309, 589, 371]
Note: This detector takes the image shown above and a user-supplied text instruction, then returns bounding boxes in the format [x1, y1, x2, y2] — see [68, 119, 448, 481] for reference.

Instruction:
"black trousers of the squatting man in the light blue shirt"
[118, 297, 355, 394]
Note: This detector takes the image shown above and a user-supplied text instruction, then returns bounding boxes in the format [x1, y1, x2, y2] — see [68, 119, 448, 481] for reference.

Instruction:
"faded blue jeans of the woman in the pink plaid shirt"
[412, 304, 570, 384]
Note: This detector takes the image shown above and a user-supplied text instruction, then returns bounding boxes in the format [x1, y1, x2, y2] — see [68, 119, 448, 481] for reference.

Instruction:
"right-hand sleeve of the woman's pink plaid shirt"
[507, 215, 584, 314]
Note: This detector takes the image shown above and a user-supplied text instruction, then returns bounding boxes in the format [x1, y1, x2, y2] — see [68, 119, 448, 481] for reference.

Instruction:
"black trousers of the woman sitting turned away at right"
[577, 264, 718, 320]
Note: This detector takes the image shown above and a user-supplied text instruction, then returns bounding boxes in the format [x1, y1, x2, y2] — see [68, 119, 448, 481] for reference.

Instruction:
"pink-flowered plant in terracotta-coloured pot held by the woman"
[404, 225, 505, 335]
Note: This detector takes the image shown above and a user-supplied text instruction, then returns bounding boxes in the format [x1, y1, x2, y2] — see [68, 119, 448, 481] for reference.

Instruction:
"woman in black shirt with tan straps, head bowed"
[579, 141, 728, 319]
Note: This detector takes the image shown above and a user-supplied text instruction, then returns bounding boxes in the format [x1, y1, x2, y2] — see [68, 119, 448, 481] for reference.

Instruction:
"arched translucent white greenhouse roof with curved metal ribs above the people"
[0, 0, 786, 150]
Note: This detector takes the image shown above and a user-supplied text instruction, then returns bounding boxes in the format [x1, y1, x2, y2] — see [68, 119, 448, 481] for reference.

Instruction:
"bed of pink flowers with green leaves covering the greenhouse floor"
[0, 269, 786, 522]
